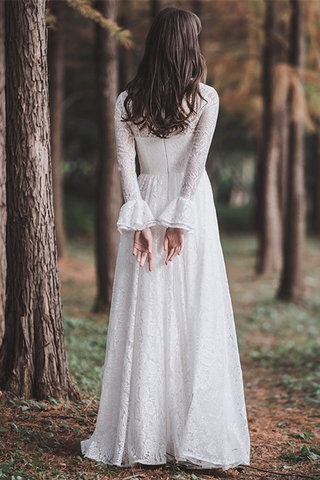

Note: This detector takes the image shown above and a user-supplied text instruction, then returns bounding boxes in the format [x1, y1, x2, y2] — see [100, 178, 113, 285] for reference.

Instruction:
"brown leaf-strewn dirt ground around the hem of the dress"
[0, 362, 320, 480]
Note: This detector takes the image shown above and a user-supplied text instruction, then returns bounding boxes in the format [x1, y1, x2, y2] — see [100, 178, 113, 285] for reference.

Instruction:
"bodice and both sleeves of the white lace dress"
[114, 83, 219, 236]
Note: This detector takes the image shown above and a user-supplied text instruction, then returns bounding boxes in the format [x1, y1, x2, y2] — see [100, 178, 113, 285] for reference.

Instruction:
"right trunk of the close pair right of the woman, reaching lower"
[277, 0, 306, 302]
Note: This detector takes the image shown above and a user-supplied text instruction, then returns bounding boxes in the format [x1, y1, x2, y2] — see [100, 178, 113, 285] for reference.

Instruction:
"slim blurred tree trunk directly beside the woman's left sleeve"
[93, 0, 121, 312]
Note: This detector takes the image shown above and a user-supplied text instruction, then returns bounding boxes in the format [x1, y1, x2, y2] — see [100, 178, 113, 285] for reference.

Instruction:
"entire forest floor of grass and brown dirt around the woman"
[0, 236, 320, 480]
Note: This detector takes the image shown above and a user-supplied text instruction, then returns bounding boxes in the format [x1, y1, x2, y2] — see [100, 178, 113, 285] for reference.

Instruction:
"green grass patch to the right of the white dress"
[222, 235, 320, 405]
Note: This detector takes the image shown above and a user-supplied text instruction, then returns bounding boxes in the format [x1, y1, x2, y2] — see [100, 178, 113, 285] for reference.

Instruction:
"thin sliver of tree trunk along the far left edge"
[0, 2, 7, 345]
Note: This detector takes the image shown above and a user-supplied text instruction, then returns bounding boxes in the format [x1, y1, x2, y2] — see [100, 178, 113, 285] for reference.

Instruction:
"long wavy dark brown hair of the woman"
[123, 7, 207, 138]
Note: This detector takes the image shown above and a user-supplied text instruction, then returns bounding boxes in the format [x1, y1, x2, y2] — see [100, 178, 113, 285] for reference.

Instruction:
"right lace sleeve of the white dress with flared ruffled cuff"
[158, 88, 219, 232]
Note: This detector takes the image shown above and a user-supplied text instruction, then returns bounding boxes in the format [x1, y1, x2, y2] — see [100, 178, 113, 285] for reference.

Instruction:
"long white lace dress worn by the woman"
[81, 83, 250, 470]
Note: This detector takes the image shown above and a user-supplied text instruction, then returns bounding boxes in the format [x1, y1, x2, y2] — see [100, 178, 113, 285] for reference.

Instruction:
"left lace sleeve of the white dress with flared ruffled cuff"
[114, 92, 157, 234]
